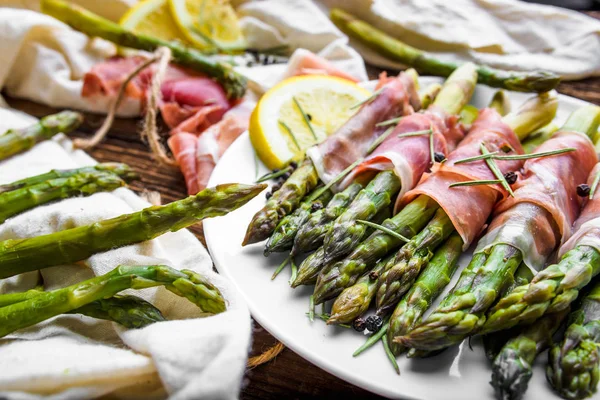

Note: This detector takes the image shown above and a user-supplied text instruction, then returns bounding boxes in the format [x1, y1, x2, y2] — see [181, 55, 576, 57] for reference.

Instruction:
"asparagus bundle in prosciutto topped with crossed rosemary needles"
[315, 96, 556, 307]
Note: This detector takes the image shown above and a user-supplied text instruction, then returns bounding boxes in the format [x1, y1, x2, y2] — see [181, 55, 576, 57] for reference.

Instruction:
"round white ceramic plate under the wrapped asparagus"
[204, 77, 600, 400]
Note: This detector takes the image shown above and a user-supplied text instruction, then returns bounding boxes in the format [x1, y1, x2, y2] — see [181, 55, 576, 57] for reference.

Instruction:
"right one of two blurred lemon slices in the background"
[169, 0, 246, 51]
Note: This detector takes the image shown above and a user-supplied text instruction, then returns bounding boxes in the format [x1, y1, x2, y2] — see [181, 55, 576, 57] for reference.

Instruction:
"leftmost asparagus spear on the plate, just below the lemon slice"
[242, 159, 319, 246]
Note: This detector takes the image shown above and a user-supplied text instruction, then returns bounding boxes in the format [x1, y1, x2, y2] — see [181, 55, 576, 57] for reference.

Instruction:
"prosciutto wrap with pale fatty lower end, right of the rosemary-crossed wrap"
[475, 132, 598, 271]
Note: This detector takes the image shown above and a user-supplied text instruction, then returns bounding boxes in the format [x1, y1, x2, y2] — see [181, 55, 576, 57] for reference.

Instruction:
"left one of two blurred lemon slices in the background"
[119, 0, 189, 44]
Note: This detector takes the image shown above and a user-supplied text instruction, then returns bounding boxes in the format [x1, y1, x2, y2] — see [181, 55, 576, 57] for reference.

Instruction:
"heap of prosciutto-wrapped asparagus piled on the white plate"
[244, 65, 600, 399]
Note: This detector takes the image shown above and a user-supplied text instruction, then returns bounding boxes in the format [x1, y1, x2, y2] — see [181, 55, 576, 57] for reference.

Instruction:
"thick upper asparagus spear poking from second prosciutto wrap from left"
[323, 171, 400, 264]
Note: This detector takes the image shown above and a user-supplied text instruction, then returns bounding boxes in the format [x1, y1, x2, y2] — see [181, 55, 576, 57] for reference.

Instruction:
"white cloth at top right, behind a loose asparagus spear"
[322, 0, 600, 79]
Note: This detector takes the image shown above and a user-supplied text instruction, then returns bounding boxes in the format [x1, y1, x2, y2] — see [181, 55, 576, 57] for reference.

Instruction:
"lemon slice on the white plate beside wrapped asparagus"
[248, 75, 370, 169]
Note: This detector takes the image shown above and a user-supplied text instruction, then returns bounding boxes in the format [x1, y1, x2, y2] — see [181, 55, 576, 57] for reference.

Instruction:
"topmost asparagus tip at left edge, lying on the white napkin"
[0, 111, 83, 160]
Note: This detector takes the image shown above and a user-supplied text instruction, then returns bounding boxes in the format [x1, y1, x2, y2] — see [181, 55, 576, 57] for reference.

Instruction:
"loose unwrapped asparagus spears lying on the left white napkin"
[0, 111, 265, 337]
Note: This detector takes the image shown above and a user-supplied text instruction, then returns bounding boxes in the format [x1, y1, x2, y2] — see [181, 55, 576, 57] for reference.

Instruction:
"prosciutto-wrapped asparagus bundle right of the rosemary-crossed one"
[396, 107, 600, 351]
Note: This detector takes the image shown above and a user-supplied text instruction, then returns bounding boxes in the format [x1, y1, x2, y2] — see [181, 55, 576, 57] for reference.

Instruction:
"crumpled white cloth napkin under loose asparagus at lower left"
[0, 108, 251, 399]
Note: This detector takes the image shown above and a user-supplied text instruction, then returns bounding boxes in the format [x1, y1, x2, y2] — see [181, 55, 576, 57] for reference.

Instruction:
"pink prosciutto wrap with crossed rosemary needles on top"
[396, 108, 523, 249]
